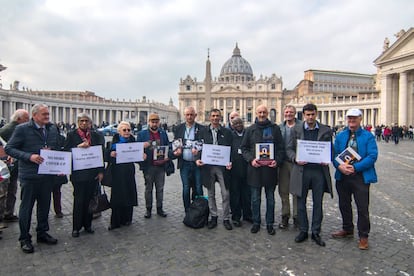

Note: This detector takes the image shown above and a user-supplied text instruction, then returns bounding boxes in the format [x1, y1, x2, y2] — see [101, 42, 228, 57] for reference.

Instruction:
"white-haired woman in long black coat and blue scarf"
[106, 121, 138, 230]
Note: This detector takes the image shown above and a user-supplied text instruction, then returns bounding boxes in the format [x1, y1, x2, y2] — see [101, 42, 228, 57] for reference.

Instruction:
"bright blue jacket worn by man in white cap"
[333, 127, 378, 184]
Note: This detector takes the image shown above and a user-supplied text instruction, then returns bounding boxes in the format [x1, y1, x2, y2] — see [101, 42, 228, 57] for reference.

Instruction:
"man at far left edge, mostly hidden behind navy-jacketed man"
[0, 109, 30, 227]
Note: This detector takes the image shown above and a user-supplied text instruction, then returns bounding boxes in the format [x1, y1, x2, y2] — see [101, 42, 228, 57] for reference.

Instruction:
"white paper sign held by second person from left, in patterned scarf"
[72, 146, 104, 171]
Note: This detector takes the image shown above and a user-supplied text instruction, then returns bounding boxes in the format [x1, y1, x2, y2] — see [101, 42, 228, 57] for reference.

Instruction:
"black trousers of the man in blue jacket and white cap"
[336, 173, 371, 238]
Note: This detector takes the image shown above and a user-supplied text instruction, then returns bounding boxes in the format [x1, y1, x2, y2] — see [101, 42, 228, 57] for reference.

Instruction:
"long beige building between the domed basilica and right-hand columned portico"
[290, 69, 381, 126]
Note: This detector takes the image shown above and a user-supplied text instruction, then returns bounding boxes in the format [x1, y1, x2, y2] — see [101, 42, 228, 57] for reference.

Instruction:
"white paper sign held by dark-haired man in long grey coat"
[296, 140, 332, 164]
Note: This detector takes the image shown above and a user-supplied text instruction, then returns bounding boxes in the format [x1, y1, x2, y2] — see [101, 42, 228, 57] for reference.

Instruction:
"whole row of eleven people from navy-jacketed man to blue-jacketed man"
[0, 101, 378, 253]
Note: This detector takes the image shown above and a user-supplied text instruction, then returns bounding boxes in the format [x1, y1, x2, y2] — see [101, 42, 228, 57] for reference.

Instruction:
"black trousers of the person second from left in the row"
[72, 180, 98, 231]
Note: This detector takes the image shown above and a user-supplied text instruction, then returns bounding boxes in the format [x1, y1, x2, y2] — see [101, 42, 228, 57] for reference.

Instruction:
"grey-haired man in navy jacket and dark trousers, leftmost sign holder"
[5, 104, 59, 253]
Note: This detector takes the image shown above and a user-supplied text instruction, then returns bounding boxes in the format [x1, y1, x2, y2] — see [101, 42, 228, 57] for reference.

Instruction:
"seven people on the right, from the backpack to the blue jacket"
[174, 104, 378, 250]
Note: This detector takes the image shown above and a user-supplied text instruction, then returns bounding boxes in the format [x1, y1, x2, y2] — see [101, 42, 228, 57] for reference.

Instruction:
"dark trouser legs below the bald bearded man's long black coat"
[251, 185, 276, 225]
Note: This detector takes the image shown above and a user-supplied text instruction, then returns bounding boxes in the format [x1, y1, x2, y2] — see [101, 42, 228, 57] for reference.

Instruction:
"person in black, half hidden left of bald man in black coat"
[230, 117, 252, 227]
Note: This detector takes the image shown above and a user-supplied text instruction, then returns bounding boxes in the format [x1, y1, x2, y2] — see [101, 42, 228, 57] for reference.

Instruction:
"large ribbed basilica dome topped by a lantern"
[220, 44, 253, 81]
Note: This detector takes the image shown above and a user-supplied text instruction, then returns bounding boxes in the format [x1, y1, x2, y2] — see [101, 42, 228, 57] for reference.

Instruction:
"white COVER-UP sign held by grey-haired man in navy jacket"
[37, 149, 72, 175]
